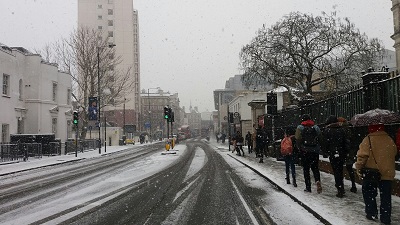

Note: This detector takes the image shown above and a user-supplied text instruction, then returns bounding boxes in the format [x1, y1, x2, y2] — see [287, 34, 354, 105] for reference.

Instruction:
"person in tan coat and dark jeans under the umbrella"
[355, 124, 397, 224]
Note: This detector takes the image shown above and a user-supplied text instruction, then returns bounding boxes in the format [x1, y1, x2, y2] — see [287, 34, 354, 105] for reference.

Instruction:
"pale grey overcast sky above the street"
[0, 0, 394, 111]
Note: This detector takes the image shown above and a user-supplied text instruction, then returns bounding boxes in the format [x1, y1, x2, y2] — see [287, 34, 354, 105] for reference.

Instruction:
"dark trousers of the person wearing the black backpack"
[301, 152, 321, 190]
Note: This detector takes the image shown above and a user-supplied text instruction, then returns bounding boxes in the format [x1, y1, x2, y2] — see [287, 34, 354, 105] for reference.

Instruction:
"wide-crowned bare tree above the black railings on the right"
[240, 12, 384, 101]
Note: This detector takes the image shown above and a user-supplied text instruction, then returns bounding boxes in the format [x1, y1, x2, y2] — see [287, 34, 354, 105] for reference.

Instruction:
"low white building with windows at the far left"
[0, 44, 72, 142]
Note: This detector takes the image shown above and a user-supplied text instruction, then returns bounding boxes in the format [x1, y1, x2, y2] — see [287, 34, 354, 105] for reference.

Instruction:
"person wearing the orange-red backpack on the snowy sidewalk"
[281, 128, 297, 187]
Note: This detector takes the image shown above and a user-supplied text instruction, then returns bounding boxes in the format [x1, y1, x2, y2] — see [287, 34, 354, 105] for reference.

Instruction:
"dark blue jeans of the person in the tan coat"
[362, 180, 392, 223]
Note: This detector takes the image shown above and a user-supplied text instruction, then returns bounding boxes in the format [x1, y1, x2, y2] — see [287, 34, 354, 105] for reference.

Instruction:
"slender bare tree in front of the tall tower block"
[38, 27, 134, 139]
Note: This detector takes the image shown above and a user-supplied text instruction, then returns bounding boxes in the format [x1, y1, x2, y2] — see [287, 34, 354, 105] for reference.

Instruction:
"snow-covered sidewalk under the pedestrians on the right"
[210, 140, 400, 225]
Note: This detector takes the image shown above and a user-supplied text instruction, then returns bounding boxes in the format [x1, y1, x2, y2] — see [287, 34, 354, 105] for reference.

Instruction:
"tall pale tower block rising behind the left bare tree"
[78, 0, 141, 127]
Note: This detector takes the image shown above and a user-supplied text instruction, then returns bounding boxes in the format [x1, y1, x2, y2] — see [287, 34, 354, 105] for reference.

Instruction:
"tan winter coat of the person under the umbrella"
[355, 130, 397, 180]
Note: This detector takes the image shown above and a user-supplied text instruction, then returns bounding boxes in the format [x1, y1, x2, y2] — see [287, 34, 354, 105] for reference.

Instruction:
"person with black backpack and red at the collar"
[295, 114, 322, 193]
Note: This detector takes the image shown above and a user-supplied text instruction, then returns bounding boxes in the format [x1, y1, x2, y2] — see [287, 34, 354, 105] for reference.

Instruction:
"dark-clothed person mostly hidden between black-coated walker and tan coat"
[338, 117, 358, 193]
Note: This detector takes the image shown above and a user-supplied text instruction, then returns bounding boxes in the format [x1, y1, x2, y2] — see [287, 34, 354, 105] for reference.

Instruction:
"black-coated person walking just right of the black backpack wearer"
[322, 116, 350, 198]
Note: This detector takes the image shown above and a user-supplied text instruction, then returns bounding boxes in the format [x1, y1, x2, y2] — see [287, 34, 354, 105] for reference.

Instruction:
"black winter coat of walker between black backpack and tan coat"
[322, 122, 350, 160]
